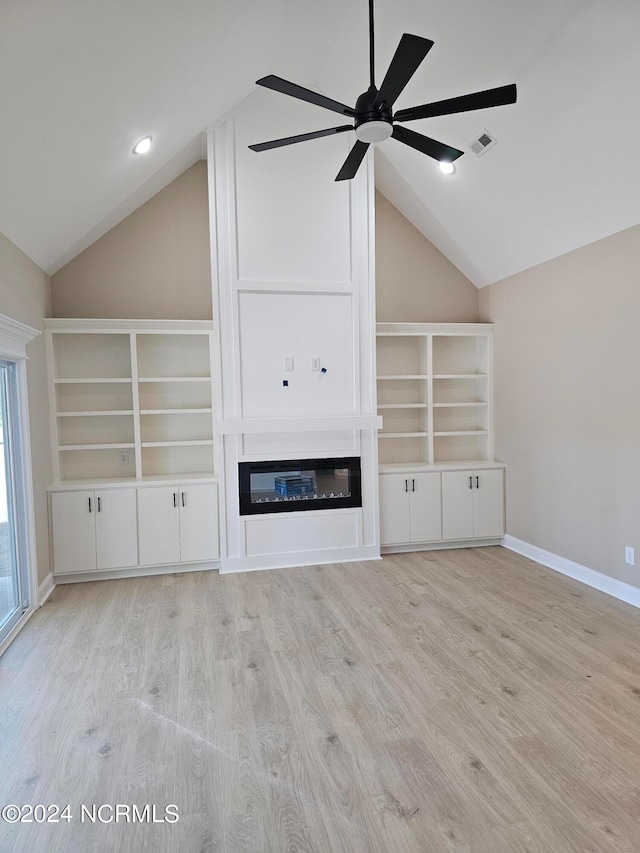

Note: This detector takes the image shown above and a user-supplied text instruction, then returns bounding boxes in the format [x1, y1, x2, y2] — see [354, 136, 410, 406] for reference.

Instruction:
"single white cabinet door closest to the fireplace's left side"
[180, 484, 220, 563]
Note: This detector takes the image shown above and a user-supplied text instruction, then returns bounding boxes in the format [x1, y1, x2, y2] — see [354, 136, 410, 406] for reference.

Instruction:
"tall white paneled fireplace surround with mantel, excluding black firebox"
[208, 92, 381, 572]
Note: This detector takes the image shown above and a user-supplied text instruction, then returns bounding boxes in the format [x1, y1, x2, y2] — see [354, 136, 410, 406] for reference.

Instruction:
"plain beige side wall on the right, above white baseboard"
[480, 226, 640, 586]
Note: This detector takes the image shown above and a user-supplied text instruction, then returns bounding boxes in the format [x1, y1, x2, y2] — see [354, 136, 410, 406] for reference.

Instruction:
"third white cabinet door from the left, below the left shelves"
[138, 486, 180, 566]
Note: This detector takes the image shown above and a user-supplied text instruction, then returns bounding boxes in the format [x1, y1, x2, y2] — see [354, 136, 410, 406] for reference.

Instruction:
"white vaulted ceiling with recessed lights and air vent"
[0, 0, 640, 286]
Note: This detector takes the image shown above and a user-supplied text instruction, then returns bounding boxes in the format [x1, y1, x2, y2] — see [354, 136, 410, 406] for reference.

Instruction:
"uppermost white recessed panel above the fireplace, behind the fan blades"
[234, 92, 355, 284]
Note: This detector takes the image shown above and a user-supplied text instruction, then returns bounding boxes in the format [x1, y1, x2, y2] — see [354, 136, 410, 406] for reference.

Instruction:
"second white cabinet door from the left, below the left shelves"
[95, 489, 138, 569]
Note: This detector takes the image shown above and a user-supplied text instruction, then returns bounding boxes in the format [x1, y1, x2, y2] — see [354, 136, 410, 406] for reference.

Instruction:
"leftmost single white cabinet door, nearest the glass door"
[51, 492, 96, 575]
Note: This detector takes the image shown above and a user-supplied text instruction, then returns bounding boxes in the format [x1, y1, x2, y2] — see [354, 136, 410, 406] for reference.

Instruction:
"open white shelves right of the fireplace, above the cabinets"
[377, 323, 493, 470]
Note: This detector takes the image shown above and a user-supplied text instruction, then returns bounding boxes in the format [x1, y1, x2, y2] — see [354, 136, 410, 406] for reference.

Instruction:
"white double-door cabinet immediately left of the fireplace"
[138, 483, 219, 566]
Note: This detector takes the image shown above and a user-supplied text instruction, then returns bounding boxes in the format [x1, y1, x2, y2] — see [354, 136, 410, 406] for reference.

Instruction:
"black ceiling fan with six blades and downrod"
[249, 0, 516, 181]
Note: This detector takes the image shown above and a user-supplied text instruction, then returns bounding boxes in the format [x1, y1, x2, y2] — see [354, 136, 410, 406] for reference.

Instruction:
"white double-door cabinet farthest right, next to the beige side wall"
[442, 469, 504, 540]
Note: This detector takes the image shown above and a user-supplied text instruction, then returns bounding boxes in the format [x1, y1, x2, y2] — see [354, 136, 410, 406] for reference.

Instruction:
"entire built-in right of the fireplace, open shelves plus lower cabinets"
[377, 323, 504, 551]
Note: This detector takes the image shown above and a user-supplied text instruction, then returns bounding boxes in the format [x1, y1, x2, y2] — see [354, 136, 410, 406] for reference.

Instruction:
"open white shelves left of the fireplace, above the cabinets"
[45, 319, 215, 482]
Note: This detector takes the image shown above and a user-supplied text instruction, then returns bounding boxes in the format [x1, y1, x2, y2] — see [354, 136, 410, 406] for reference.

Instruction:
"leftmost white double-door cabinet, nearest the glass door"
[51, 489, 138, 574]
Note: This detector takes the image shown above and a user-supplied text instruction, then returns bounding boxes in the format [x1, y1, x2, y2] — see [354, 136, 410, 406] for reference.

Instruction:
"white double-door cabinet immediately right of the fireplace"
[380, 472, 442, 545]
